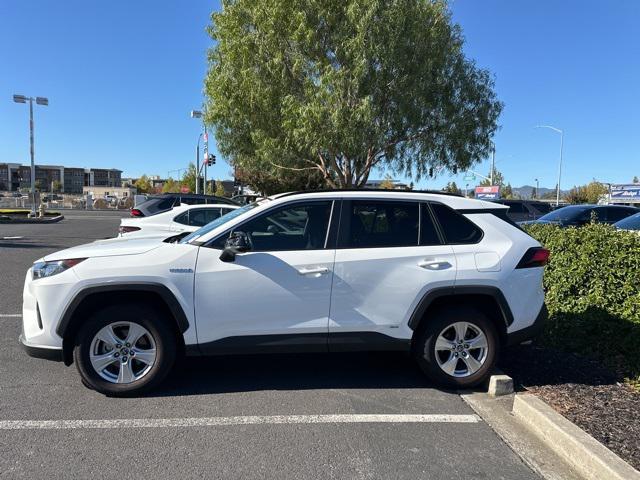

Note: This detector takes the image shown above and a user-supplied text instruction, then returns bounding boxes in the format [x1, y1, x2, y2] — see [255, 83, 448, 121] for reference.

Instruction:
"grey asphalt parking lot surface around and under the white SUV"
[0, 212, 538, 479]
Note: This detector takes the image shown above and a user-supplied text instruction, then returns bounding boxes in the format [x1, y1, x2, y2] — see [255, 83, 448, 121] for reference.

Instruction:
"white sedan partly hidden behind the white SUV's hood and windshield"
[118, 204, 238, 239]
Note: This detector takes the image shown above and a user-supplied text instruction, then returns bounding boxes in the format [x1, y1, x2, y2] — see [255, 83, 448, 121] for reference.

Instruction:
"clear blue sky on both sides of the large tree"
[0, 0, 640, 188]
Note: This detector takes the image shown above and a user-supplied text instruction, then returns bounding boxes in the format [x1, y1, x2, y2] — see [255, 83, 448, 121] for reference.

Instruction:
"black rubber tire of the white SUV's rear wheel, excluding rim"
[412, 306, 499, 388]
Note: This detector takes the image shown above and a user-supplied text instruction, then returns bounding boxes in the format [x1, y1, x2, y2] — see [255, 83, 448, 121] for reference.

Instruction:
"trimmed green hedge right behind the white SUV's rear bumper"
[526, 223, 640, 386]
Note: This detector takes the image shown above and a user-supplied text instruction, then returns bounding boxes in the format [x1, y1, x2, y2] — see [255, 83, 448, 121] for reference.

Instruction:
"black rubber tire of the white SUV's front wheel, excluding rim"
[73, 303, 176, 397]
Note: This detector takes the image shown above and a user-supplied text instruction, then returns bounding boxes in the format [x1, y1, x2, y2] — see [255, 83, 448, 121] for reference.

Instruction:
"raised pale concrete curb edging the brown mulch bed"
[513, 393, 640, 480]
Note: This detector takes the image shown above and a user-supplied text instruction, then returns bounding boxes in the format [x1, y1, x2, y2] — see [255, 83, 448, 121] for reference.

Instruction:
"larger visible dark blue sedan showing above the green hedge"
[520, 205, 640, 227]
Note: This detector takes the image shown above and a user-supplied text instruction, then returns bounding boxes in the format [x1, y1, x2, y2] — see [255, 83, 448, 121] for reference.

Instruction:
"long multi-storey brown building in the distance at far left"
[0, 163, 122, 193]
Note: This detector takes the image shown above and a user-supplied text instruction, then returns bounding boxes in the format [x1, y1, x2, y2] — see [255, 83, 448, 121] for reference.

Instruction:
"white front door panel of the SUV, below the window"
[195, 247, 334, 343]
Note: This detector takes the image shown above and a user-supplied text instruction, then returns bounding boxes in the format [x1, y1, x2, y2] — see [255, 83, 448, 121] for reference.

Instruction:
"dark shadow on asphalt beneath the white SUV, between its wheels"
[146, 352, 442, 397]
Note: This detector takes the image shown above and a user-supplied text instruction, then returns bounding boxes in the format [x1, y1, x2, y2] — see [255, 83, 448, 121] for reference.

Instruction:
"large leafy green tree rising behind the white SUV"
[205, 0, 502, 188]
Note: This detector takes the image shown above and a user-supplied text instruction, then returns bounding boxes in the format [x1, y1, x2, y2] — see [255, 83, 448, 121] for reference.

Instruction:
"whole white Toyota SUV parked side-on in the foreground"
[20, 190, 549, 395]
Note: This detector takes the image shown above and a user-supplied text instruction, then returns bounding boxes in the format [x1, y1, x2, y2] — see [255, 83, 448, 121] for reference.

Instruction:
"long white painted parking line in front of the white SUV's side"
[0, 414, 480, 430]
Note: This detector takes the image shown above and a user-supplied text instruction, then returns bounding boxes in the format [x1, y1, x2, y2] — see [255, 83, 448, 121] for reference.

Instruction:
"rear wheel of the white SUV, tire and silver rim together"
[413, 307, 499, 388]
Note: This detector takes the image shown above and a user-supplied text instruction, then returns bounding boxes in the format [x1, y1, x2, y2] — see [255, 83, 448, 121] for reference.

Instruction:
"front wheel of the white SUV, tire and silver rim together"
[74, 305, 176, 396]
